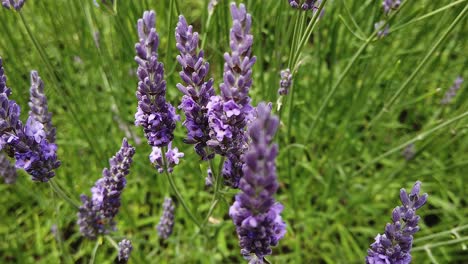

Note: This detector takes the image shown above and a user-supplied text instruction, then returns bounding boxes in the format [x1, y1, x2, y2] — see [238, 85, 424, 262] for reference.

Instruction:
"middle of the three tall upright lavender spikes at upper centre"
[175, 16, 215, 160]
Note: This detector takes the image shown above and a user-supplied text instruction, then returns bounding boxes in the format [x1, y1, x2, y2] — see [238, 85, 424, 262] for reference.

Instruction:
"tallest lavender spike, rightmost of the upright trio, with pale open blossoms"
[207, 4, 256, 188]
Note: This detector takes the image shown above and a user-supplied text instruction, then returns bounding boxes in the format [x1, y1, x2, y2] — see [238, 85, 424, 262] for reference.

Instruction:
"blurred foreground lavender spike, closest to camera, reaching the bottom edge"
[229, 103, 286, 263]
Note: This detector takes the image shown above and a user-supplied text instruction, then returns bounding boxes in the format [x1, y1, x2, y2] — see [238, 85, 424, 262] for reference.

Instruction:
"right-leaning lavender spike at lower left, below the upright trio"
[77, 138, 135, 239]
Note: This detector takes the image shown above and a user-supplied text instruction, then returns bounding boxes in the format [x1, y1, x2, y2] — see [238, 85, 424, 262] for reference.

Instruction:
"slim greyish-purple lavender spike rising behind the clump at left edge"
[28, 71, 55, 143]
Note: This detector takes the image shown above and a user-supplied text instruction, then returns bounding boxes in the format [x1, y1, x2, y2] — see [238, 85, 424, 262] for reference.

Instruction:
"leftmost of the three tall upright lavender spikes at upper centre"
[135, 11, 179, 147]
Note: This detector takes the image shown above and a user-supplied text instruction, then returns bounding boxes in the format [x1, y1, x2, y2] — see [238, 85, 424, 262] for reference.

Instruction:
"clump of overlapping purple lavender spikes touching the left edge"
[0, 58, 60, 182]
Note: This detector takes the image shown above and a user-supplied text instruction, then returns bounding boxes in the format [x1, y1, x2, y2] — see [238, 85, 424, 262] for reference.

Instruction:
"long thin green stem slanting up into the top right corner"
[368, 5, 468, 128]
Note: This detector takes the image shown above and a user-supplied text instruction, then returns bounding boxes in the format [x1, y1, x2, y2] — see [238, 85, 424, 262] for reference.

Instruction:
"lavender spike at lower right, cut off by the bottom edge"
[366, 181, 427, 264]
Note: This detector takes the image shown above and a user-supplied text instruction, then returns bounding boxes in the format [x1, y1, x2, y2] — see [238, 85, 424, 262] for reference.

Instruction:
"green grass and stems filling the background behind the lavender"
[0, 0, 468, 263]
